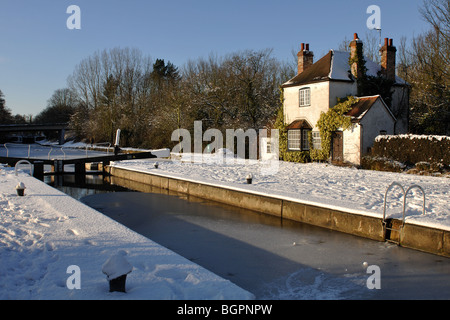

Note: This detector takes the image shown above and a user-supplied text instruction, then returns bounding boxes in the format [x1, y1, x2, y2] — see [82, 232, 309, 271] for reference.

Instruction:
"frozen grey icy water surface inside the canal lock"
[82, 192, 450, 300]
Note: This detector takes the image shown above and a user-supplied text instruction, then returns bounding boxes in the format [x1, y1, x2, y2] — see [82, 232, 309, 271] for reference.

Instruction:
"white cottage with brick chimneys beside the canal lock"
[282, 34, 409, 165]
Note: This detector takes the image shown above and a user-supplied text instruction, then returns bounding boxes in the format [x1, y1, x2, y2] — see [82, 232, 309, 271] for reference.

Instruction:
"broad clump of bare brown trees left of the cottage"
[64, 48, 293, 148]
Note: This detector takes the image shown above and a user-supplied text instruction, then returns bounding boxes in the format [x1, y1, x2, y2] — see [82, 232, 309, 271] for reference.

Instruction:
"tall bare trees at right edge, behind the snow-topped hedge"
[404, 0, 450, 135]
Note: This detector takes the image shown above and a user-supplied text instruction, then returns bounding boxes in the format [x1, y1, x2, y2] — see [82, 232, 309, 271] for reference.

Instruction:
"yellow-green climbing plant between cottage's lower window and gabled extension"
[310, 96, 359, 161]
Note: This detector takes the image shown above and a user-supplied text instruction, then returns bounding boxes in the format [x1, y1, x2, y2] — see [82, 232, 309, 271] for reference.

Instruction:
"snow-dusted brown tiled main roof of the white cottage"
[282, 50, 406, 87]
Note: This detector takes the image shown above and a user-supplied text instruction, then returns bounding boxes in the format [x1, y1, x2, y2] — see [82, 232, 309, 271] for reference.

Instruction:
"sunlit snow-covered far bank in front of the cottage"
[113, 154, 450, 230]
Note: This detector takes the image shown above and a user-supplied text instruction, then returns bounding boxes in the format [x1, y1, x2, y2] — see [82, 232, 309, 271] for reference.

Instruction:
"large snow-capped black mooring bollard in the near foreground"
[102, 250, 133, 292]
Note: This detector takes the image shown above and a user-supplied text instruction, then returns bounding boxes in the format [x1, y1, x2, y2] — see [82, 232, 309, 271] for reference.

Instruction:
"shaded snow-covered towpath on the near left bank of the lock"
[0, 168, 253, 300]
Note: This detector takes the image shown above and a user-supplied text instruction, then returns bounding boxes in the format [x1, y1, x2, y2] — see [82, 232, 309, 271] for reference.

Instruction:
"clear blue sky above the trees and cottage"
[0, 0, 428, 115]
